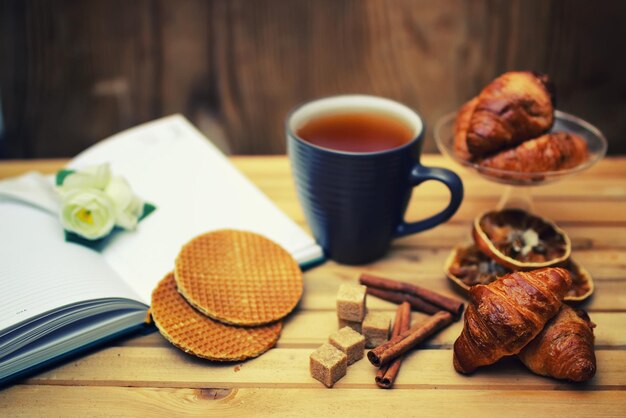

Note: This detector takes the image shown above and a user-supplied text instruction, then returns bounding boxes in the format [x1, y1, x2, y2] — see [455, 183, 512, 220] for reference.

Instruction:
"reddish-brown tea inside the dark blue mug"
[296, 112, 415, 152]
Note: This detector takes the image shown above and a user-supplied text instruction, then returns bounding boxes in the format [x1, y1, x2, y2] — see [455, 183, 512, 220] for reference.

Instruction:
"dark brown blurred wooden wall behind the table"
[0, 0, 626, 158]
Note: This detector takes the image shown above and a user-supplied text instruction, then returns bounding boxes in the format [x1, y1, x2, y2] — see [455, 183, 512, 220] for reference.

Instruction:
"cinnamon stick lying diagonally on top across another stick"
[367, 311, 454, 367]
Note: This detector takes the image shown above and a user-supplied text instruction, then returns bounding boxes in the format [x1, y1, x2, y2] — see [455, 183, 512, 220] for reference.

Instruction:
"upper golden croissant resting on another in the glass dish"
[467, 71, 554, 158]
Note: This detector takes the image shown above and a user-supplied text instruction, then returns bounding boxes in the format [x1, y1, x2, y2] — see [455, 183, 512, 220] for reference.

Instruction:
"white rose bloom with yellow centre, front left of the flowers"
[61, 188, 115, 240]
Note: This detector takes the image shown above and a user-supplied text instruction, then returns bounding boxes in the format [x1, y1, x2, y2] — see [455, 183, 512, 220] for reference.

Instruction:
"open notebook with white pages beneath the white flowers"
[0, 115, 323, 384]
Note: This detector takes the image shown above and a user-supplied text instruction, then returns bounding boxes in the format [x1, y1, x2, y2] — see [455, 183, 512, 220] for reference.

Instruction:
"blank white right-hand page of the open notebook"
[71, 116, 322, 300]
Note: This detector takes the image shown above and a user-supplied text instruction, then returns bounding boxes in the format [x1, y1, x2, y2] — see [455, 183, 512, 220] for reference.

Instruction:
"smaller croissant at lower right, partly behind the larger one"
[518, 305, 596, 382]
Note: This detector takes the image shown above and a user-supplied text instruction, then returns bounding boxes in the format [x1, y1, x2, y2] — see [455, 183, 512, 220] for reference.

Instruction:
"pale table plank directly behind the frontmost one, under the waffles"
[20, 344, 626, 390]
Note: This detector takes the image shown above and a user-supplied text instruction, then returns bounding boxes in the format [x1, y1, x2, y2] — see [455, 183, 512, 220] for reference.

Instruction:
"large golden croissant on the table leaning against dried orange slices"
[453, 268, 572, 373]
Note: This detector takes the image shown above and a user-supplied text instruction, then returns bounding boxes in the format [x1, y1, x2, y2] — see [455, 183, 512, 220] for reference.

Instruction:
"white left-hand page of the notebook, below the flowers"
[0, 199, 138, 330]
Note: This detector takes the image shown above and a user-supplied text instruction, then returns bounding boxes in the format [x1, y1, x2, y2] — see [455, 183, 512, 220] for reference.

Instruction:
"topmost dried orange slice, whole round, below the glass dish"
[472, 209, 572, 270]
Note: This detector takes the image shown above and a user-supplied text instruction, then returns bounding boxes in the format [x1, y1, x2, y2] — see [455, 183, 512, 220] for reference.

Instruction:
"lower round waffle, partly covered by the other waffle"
[150, 273, 282, 361]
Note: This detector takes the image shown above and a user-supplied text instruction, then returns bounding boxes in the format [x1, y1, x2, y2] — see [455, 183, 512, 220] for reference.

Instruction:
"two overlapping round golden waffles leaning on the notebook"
[150, 230, 303, 361]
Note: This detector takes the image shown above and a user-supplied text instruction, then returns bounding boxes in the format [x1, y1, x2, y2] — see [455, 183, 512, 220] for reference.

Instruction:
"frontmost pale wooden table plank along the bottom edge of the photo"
[0, 386, 626, 418]
